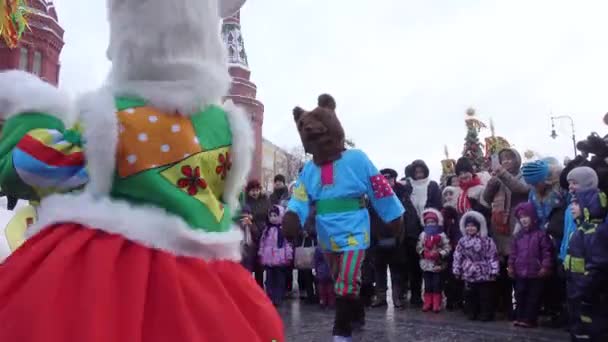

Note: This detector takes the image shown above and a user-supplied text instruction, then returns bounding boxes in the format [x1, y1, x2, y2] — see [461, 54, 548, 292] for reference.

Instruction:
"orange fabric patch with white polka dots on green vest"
[117, 107, 202, 178]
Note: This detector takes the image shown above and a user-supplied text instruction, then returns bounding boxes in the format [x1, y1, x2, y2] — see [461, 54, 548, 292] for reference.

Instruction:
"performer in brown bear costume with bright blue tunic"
[283, 94, 404, 341]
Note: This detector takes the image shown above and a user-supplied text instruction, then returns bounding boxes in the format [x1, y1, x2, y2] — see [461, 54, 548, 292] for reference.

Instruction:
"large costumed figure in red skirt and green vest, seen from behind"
[0, 0, 285, 342]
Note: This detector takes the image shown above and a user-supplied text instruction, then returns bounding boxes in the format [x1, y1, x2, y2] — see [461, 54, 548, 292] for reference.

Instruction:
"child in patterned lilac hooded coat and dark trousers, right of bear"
[453, 211, 499, 322]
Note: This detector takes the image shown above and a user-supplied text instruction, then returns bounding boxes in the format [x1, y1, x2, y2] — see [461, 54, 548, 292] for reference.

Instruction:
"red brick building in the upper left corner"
[0, 0, 64, 85]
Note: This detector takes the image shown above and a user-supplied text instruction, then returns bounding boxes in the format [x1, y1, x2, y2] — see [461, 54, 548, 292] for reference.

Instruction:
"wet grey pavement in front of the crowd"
[279, 300, 569, 342]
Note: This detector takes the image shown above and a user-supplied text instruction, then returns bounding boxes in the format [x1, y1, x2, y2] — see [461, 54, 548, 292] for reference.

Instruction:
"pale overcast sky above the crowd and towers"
[55, 0, 608, 177]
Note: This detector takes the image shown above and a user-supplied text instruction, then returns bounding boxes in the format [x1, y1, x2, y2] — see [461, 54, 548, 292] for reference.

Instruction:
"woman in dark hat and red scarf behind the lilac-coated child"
[456, 157, 490, 221]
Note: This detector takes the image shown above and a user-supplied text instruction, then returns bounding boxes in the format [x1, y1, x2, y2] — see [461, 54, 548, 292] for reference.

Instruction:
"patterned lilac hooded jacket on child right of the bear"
[452, 211, 499, 283]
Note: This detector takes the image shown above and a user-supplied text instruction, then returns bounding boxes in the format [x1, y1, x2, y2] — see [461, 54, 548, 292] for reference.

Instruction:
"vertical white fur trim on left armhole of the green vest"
[78, 88, 118, 195]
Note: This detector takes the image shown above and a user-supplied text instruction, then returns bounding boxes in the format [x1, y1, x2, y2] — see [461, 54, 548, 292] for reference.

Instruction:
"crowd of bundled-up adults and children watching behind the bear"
[241, 148, 608, 341]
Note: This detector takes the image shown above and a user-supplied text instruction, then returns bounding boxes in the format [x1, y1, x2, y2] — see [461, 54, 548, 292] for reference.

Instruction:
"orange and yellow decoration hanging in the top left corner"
[0, 0, 28, 49]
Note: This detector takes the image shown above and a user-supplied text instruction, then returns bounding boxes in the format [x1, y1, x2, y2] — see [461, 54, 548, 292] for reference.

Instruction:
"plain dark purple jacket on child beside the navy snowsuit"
[509, 224, 553, 278]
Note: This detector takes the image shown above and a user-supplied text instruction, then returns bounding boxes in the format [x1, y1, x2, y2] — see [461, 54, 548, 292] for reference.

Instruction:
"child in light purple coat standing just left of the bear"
[258, 205, 293, 306]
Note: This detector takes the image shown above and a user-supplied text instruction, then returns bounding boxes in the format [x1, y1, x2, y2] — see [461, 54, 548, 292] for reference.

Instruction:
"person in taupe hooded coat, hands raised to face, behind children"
[483, 148, 530, 316]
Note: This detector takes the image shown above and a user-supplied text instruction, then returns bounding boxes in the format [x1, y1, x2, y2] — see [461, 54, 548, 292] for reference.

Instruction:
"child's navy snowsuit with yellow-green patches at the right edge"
[564, 189, 608, 303]
